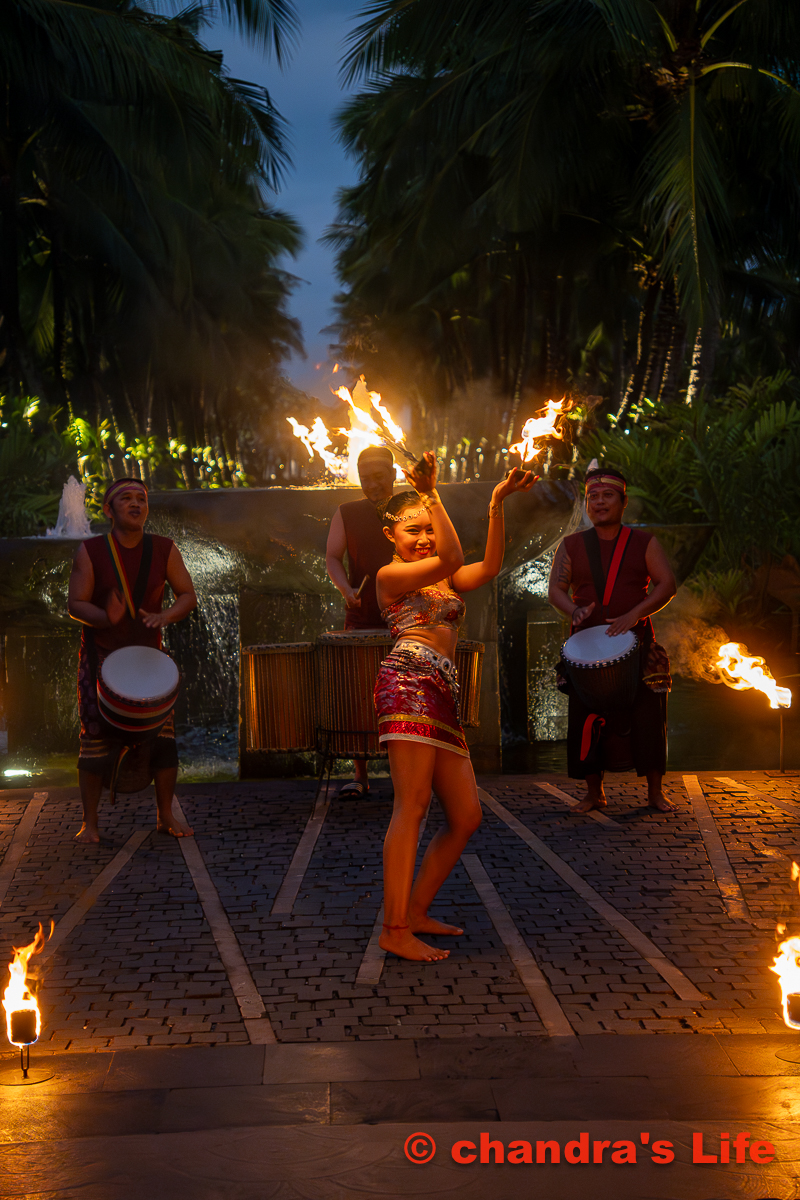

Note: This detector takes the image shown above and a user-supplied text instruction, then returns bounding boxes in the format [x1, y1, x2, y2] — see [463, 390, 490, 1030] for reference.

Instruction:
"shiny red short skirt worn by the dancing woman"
[374, 640, 469, 758]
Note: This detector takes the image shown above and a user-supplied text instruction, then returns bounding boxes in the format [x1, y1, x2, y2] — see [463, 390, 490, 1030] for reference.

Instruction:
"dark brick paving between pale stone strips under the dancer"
[0, 768, 800, 1050]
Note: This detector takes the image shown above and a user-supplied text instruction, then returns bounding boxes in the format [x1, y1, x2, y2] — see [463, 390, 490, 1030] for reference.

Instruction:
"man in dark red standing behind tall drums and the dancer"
[325, 446, 395, 797]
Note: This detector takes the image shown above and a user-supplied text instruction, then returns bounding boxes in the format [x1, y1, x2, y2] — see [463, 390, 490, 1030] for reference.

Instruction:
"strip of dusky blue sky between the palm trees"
[212, 0, 360, 400]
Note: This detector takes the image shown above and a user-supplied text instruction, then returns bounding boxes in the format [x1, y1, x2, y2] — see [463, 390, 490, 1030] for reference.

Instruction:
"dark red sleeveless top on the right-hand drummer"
[564, 529, 654, 642]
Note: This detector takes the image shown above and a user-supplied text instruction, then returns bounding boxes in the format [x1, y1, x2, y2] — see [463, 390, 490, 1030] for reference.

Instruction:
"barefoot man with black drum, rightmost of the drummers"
[548, 467, 675, 812]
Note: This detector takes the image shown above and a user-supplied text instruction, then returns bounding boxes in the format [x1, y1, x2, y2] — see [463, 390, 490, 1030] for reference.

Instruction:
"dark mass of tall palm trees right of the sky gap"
[330, 0, 800, 442]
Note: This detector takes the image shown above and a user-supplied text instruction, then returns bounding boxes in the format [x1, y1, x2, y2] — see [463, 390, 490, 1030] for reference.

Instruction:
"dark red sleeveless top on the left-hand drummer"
[82, 534, 174, 650]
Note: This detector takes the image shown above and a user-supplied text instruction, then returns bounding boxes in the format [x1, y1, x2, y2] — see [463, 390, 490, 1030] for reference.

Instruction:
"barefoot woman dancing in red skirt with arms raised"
[375, 451, 534, 962]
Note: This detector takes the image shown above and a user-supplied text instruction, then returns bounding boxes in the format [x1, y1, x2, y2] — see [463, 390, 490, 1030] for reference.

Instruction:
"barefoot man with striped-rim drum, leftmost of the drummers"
[68, 479, 197, 842]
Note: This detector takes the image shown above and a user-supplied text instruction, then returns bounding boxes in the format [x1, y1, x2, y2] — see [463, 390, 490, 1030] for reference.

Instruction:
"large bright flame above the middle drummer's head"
[287, 376, 405, 484]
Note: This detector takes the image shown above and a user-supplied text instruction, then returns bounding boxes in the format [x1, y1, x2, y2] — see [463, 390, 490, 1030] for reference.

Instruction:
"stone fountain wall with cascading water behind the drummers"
[0, 481, 579, 786]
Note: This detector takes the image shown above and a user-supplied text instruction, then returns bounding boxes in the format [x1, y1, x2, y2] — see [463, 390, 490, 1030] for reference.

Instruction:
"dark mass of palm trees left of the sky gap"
[0, 0, 299, 463]
